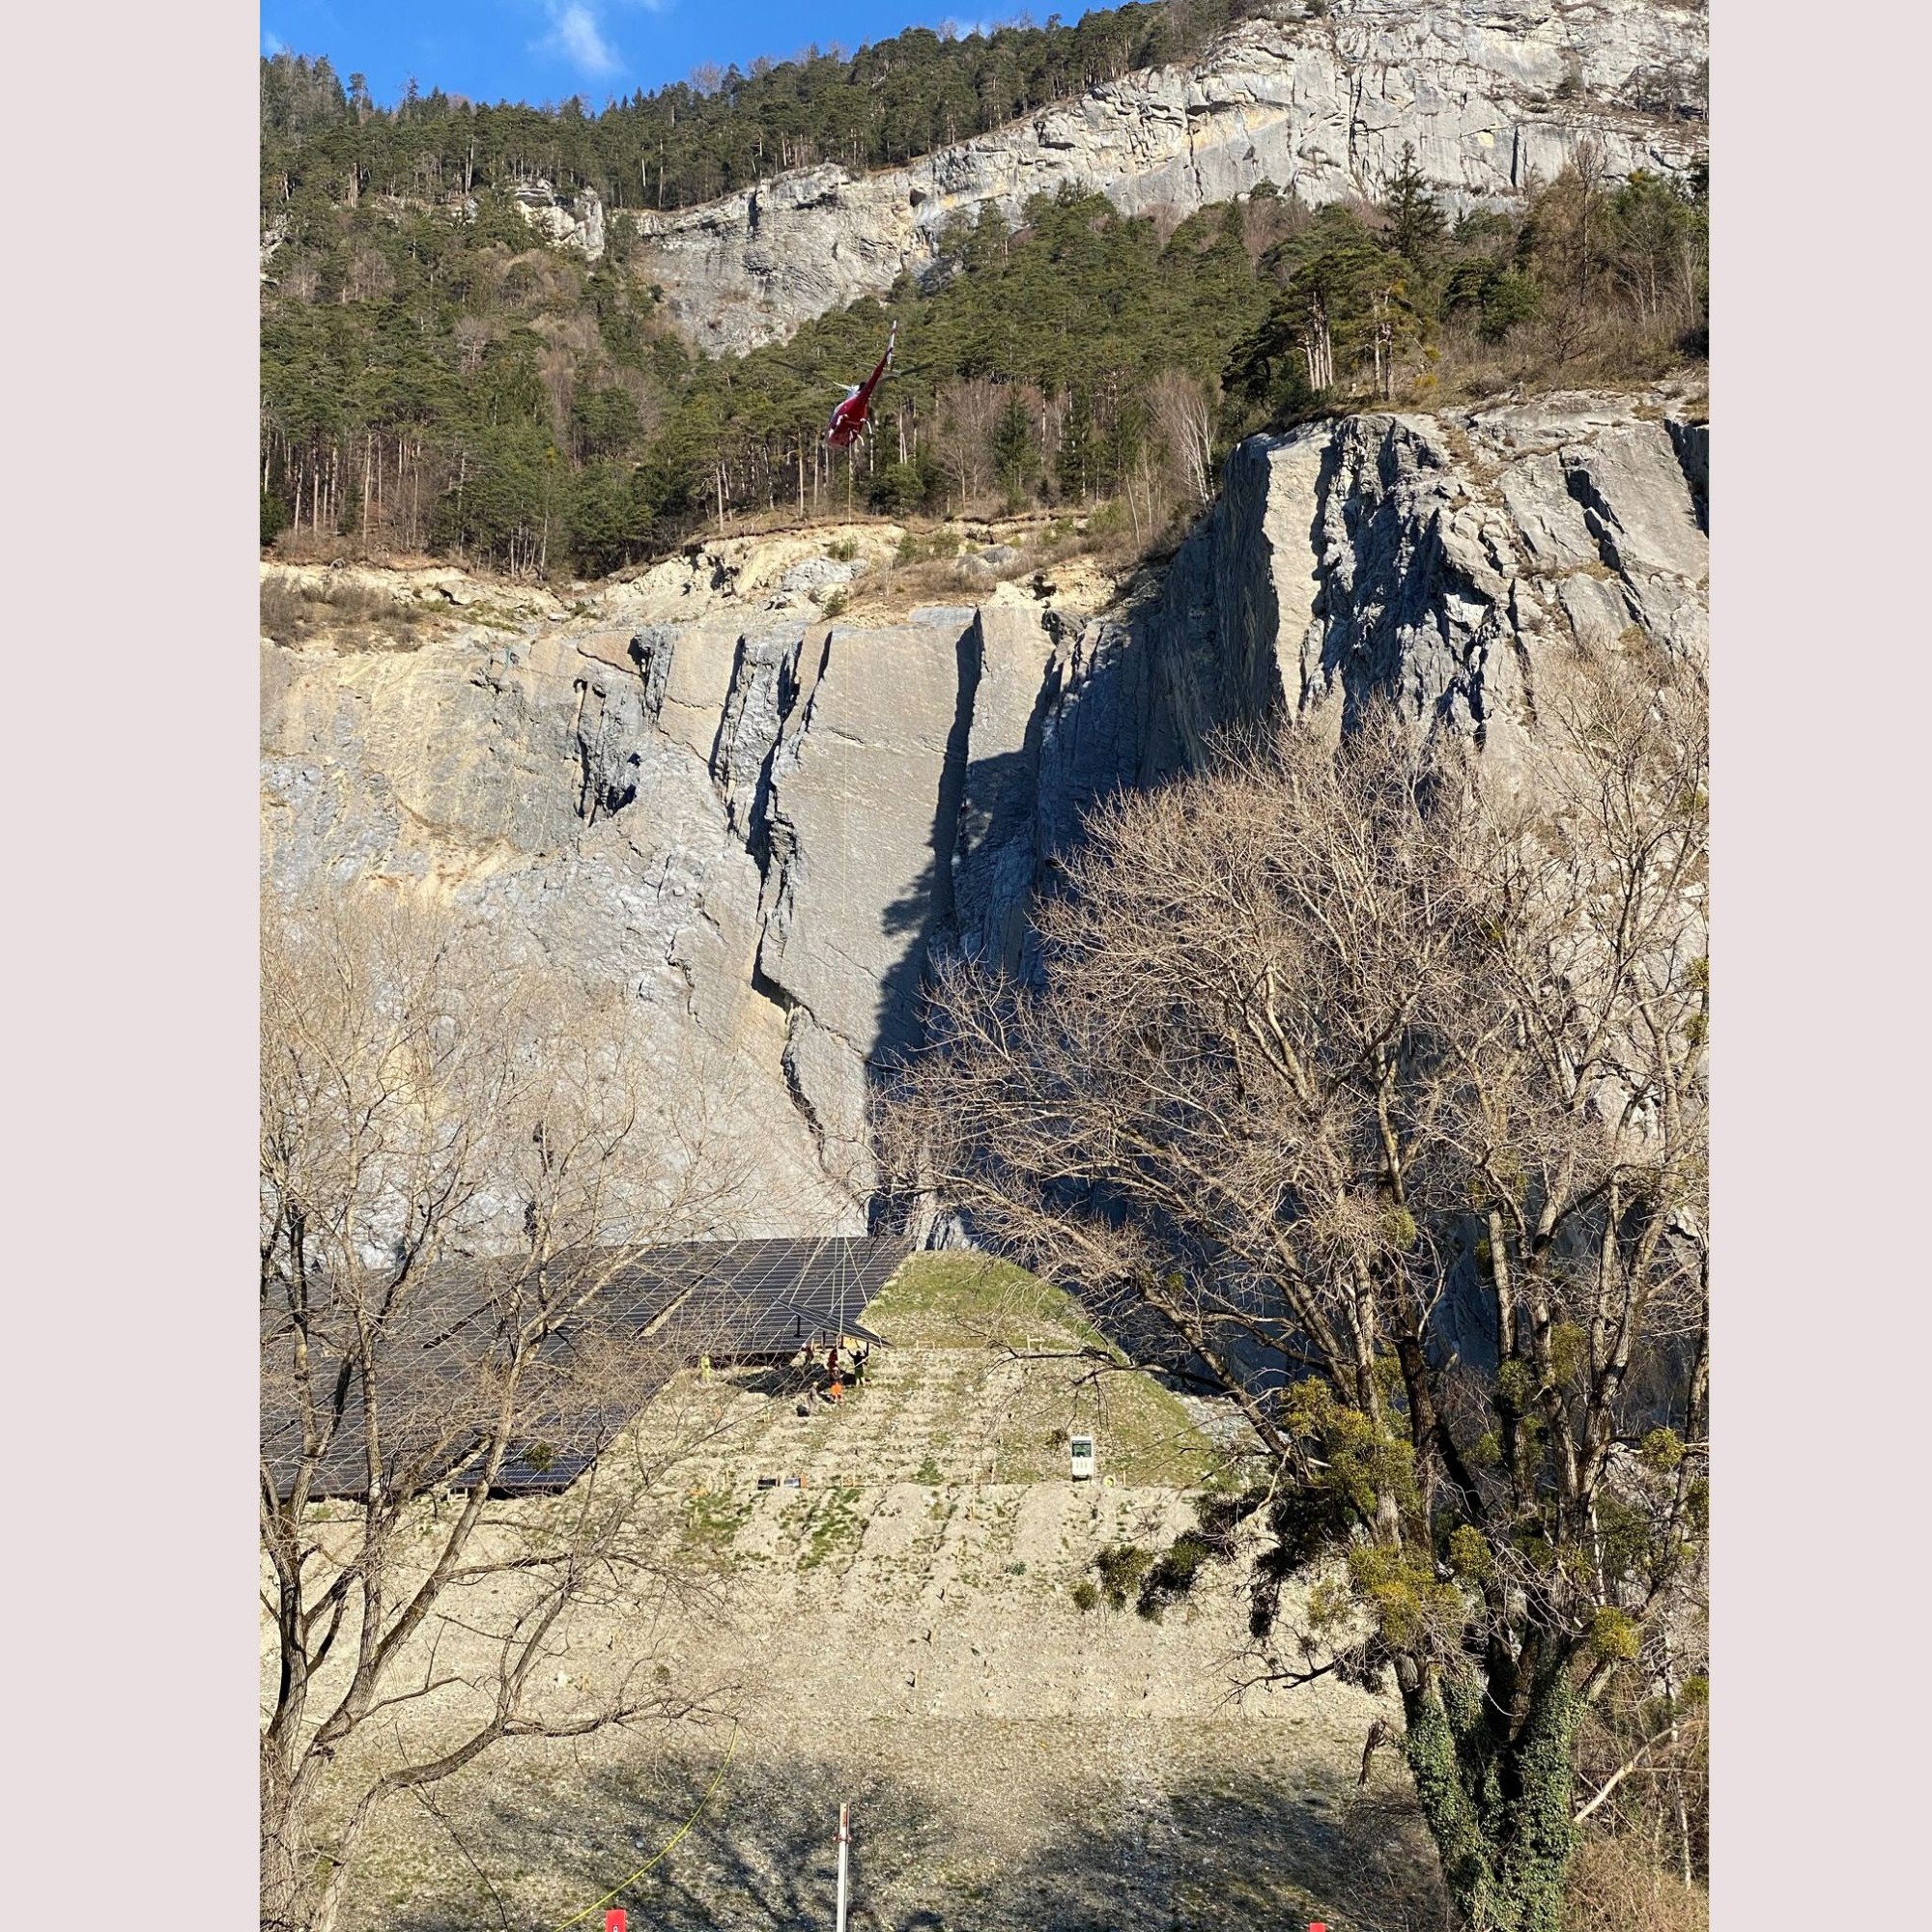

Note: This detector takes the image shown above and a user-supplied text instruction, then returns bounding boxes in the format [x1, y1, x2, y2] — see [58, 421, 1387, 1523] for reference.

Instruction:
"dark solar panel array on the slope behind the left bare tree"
[261, 1236, 910, 1497]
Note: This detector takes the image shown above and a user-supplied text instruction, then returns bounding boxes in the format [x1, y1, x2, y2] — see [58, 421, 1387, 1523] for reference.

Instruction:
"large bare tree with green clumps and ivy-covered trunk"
[885, 659, 1706, 1932]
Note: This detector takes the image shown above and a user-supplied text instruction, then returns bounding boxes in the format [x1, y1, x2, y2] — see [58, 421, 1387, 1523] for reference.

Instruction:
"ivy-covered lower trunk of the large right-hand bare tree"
[1403, 1663, 1582, 1932]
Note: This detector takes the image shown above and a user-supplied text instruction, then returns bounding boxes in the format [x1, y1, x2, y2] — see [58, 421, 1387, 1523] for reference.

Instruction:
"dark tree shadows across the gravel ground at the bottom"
[381, 1739, 1441, 1932]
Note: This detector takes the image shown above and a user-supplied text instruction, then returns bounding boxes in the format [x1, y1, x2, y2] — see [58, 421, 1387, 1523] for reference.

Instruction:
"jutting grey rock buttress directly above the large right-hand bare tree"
[1128, 379, 1710, 769]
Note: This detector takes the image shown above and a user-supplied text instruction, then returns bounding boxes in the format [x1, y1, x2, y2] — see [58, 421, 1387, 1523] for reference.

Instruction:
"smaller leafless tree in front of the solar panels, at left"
[261, 889, 761, 1932]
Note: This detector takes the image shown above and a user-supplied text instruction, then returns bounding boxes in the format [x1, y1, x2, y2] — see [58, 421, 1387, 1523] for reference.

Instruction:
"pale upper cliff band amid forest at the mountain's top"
[626, 0, 1708, 350]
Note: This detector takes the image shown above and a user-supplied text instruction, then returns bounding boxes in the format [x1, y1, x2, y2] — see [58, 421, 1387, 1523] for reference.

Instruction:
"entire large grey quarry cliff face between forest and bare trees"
[263, 392, 1708, 1233]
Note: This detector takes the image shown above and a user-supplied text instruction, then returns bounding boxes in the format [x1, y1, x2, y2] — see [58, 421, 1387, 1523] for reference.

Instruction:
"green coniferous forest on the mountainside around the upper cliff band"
[261, 13, 1708, 578]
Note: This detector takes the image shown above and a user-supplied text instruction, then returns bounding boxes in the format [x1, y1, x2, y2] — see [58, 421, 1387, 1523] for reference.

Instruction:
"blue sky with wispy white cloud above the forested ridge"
[261, 0, 1059, 106]
